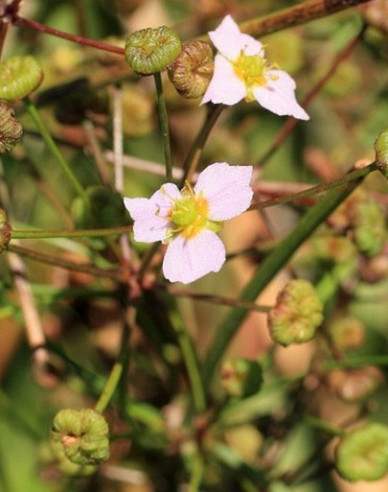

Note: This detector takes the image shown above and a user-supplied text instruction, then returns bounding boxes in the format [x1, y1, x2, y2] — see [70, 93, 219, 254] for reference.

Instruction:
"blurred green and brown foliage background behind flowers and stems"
[0, 0, 388, 492]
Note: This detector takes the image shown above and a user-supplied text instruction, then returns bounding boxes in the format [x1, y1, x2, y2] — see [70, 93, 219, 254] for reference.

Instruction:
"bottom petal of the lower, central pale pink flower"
[163, 229, 225, 284]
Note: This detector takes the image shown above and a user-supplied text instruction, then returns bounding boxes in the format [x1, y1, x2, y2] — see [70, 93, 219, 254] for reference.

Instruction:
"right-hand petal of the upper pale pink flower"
[252, 70, 310, 120]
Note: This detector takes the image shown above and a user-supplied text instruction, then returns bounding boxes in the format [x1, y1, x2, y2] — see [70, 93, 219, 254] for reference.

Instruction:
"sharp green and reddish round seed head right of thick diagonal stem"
[268, 279, 323, 346]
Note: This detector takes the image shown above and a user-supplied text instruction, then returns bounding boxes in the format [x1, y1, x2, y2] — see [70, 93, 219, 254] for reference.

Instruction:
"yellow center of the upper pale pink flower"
[233, 50, 267, 101]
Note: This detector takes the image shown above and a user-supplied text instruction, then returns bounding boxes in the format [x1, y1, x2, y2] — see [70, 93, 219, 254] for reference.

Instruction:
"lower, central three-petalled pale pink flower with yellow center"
[124, 162, 253, 284]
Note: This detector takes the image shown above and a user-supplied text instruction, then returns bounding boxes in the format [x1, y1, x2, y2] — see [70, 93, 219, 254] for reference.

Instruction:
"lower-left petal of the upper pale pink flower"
[201, 55, 247, 106]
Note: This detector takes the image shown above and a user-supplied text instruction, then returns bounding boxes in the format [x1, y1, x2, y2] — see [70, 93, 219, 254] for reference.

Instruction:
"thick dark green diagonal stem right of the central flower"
[202, 180, 368, 385]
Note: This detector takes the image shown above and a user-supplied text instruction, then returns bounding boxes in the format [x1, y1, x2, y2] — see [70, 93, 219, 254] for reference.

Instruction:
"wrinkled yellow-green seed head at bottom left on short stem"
[50, 408, 109, 466]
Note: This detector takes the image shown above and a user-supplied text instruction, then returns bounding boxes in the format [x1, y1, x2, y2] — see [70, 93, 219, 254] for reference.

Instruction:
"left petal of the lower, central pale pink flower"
[124, 198, 169, 243]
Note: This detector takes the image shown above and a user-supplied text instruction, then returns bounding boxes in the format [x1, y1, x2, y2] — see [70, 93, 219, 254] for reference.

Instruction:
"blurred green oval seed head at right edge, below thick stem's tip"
[353, 199, 387, 256]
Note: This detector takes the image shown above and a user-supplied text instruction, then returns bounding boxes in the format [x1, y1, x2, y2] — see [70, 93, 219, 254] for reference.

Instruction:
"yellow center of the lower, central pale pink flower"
[170, 183, 209, 239]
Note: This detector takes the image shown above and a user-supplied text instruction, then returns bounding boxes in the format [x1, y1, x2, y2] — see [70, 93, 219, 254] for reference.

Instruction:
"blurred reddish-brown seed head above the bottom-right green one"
[327, 366, 384, 403]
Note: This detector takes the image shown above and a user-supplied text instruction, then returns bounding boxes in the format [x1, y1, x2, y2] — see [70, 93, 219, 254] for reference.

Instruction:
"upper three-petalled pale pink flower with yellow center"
[201, 15, 309, 120]
